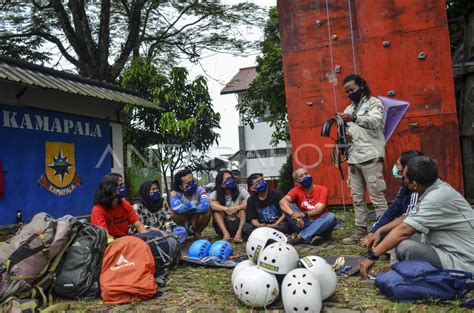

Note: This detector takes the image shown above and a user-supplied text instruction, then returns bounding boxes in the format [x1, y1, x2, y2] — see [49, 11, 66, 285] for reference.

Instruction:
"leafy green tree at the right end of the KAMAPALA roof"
[122, 58, 220, 195]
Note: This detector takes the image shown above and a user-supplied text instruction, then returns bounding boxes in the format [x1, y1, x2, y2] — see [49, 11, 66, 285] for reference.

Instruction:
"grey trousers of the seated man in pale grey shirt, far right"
[395, 239, 443, 268]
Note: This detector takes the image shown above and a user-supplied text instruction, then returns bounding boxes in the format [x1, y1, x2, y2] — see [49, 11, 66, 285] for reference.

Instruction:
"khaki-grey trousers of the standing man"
[348, 161, 388, 227]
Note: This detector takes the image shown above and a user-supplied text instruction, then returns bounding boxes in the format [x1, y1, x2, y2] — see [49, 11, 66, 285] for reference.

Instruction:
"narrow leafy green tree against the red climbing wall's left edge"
[237, 7, 290, 145]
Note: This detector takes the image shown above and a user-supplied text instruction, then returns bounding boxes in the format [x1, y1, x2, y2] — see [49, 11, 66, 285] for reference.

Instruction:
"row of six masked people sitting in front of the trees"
[91, 168, 337, 244]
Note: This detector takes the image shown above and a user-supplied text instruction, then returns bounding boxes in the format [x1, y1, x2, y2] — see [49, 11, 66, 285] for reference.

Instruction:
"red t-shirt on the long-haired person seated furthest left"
[91, 199, 140, 237]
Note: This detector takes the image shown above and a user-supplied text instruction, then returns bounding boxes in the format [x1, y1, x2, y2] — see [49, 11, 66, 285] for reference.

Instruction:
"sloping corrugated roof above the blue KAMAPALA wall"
[0, 56, 160, 109]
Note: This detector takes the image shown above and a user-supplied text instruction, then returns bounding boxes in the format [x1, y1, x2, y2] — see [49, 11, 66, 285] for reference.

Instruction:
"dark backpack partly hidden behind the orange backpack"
[135, 231, 181, 277]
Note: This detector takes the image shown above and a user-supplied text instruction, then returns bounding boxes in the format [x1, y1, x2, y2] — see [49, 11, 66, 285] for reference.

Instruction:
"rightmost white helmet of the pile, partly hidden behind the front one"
[300, 255, 337, 301]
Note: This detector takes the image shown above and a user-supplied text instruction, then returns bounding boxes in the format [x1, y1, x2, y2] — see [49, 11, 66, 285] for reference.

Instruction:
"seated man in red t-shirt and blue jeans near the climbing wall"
[280, 168, 337, 245]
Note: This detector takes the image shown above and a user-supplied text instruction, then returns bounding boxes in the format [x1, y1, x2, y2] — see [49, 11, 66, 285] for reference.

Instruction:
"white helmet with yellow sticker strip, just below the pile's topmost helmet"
[257, 242, 300, 275]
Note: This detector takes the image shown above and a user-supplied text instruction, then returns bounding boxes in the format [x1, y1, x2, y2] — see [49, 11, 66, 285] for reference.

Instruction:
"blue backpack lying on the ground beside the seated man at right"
[375, 260, 472, 302]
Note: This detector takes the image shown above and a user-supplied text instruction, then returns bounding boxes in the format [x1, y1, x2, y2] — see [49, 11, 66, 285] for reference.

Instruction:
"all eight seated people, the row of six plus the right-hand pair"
[91, 147, 474, 277]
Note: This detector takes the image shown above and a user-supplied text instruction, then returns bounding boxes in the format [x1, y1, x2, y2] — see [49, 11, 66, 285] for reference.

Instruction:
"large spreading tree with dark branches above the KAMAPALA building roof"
[0, 0, 261, 83]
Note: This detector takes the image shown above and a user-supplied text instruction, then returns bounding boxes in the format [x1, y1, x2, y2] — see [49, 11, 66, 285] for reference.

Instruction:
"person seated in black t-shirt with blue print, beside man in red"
[244, 173, 289, 237]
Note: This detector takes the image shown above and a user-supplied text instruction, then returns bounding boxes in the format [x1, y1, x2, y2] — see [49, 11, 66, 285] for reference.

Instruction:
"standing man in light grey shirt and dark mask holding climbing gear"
[341, 75, 387, 244]
